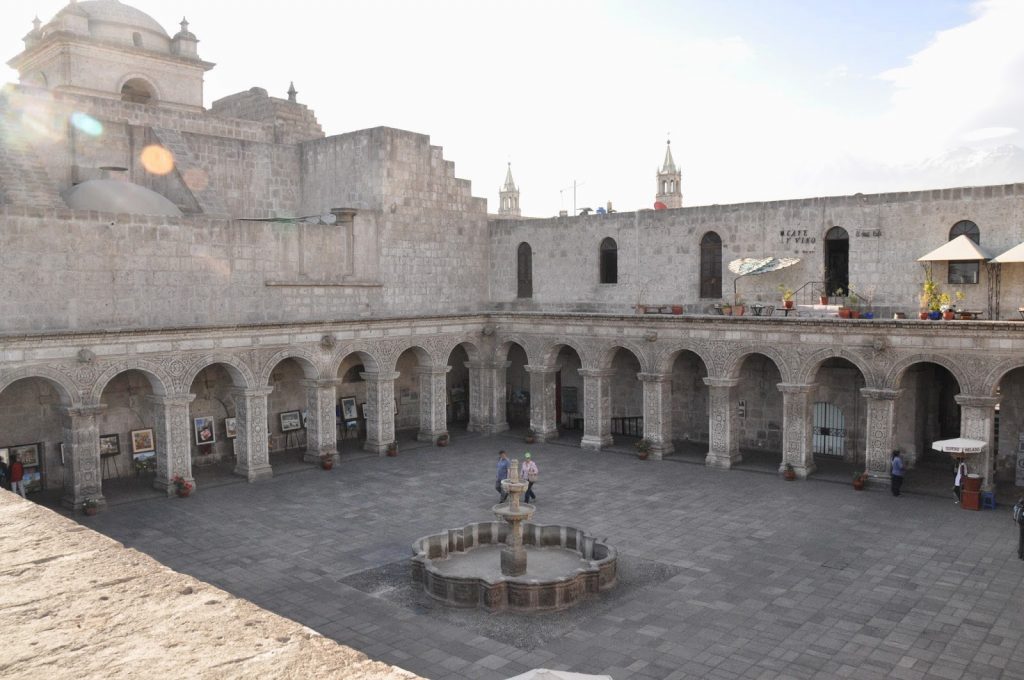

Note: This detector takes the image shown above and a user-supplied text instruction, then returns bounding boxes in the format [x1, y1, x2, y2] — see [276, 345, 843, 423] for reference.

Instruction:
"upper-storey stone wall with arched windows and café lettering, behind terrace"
[489, 184, 1024, 318]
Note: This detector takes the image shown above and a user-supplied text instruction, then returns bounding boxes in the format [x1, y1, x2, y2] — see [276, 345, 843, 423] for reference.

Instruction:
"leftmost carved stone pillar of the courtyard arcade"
[60, 403, 106, 510]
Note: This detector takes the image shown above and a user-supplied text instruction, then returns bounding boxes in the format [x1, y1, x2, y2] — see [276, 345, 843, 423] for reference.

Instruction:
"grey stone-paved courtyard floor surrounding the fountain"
[79, 435, 1024, 680]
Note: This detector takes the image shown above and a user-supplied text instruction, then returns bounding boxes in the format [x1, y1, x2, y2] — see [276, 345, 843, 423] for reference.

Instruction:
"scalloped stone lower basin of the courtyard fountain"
[412, 521, 617, 611]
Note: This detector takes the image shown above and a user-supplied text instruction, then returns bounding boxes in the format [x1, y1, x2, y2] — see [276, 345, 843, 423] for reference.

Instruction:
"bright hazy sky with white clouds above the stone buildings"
[0, 0, 1024, 217]
